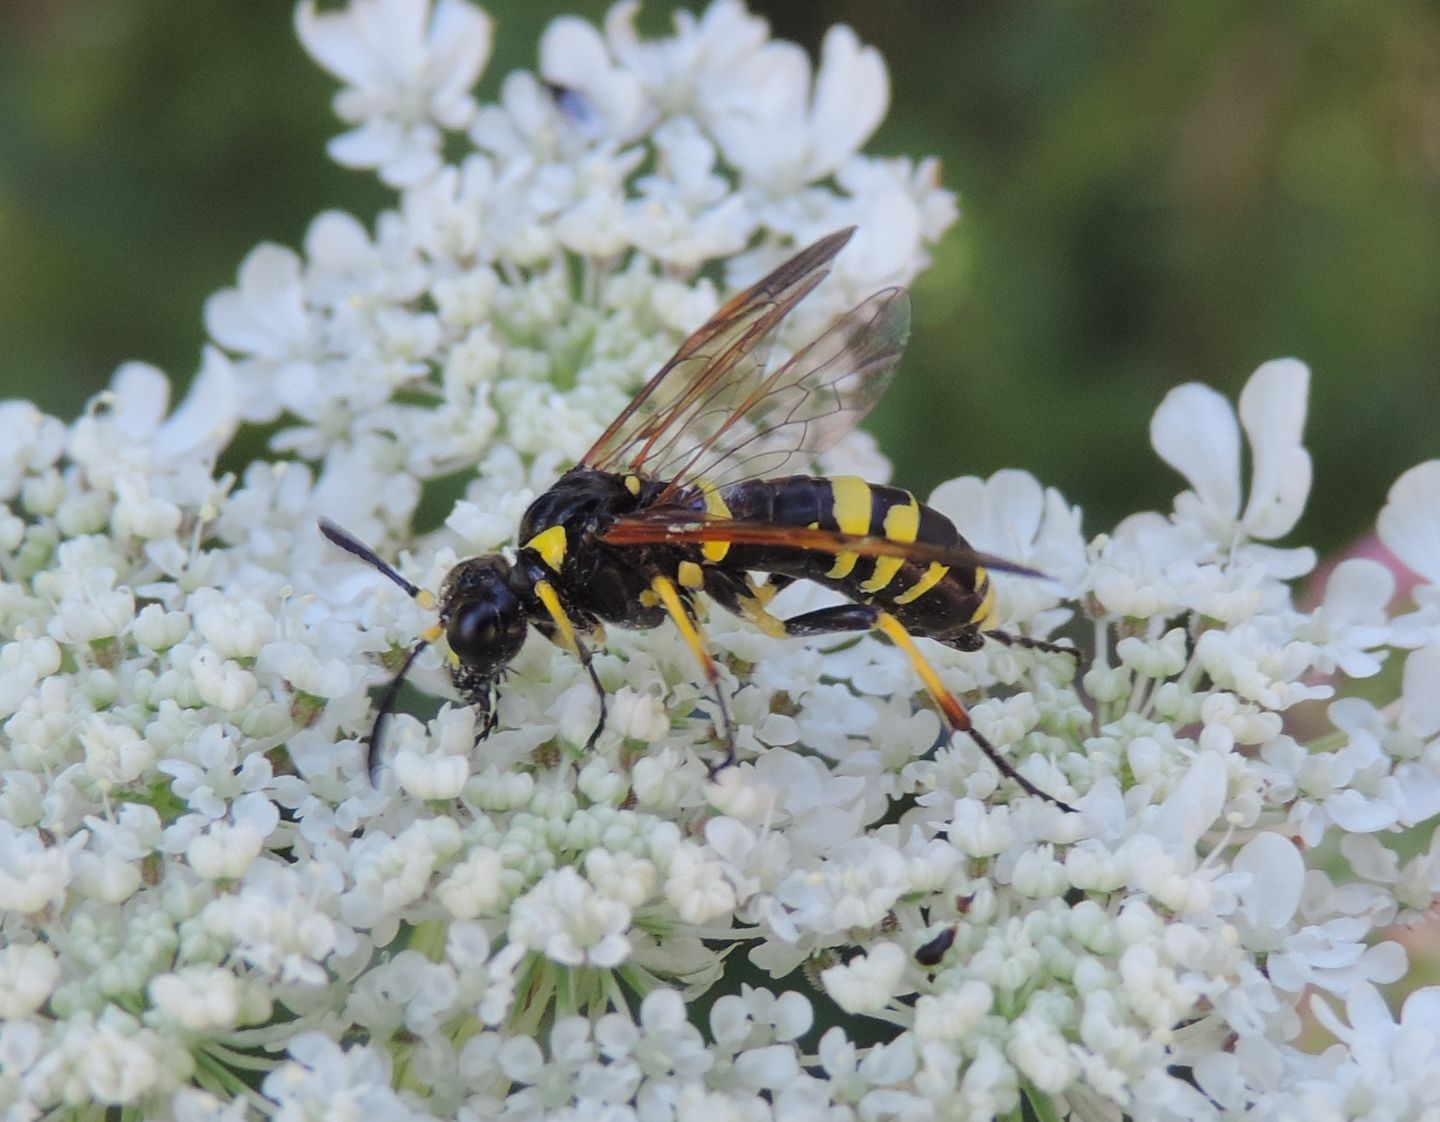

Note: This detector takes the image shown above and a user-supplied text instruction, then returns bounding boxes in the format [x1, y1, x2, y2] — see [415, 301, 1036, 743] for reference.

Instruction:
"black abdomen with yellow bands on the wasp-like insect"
[708, 475, 992, 639]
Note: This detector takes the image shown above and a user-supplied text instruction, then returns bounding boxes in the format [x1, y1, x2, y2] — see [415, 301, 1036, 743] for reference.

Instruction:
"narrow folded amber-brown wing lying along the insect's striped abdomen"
[600, 507, 1044, 578]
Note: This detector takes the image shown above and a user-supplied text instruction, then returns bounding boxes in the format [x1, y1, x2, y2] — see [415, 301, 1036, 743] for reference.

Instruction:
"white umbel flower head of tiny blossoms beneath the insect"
[0, 0, 1440, 1122]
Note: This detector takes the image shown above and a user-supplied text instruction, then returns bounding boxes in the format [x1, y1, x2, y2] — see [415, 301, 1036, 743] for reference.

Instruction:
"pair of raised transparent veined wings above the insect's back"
[580, 230, 910, 503]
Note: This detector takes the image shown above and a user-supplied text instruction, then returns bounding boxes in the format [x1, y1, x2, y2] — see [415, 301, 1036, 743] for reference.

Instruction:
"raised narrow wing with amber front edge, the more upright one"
[580, 228, 854, 478]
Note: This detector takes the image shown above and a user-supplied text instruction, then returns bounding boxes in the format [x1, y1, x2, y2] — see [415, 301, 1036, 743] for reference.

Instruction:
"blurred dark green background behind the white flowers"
[0, 0, 1440, 549]
